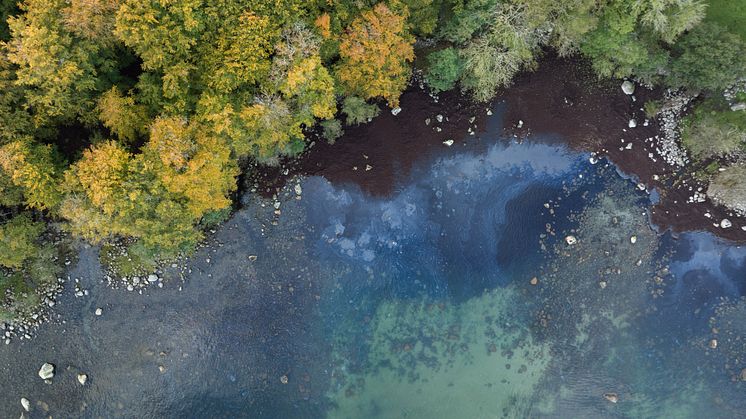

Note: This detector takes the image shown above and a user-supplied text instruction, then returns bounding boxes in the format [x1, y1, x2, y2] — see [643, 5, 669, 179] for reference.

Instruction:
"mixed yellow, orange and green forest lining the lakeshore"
[0, 0, 746, 318]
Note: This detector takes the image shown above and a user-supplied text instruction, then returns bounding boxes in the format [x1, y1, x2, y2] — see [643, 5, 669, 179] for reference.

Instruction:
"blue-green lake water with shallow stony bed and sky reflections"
[0, 116, 746, 418]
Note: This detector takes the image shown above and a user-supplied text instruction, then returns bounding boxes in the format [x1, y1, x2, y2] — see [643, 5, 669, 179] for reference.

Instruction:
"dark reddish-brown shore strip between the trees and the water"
[253, 54, 746, 242]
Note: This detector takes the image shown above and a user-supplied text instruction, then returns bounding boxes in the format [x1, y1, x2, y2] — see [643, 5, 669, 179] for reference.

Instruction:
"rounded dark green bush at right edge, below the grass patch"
[666, 23, 746, 90]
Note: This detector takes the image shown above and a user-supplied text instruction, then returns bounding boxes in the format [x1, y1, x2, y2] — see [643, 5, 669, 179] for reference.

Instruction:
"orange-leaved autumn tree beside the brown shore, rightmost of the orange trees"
[336, 3, 414, 107]
